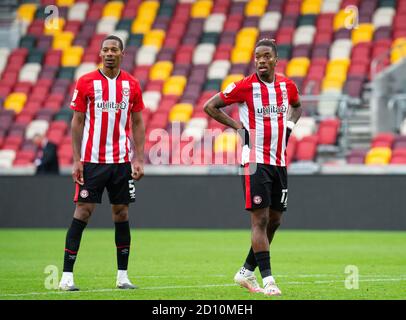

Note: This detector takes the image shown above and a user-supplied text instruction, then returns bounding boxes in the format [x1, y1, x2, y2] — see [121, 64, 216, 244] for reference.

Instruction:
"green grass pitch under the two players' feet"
[0, 229, 406, 300]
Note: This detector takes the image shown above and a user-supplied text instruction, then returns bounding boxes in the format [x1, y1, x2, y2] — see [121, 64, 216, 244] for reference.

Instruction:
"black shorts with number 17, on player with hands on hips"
[241, 163, 288, 212]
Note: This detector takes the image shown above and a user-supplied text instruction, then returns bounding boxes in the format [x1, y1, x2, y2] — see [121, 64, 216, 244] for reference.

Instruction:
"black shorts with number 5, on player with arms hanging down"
[74, 162, 135, 204]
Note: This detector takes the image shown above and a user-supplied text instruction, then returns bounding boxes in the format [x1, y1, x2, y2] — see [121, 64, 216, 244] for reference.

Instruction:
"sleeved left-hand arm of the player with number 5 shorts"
[70, 77, 87, 185]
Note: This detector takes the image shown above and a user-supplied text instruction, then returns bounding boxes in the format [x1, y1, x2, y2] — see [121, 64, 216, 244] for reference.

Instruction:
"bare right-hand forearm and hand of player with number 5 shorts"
[131, 111, 145, 180]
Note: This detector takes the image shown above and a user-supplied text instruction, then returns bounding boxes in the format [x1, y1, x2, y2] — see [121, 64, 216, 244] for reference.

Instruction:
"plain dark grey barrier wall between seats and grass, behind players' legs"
[0, 175, 406, 230]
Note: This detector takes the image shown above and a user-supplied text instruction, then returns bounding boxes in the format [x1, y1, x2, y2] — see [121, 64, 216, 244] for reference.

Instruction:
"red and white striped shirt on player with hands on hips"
[220, 73, 299, 167]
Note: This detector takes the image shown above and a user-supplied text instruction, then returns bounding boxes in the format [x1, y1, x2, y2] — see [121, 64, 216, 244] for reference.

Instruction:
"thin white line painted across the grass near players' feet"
[0, 277, 406, 297]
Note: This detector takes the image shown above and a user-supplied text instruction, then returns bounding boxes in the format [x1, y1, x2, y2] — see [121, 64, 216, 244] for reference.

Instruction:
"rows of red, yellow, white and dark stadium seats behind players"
[0, 0, 406, 168]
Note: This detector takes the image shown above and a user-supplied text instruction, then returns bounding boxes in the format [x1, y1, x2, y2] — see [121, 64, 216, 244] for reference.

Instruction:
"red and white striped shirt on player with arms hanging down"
[70, 70, 144, 163]
